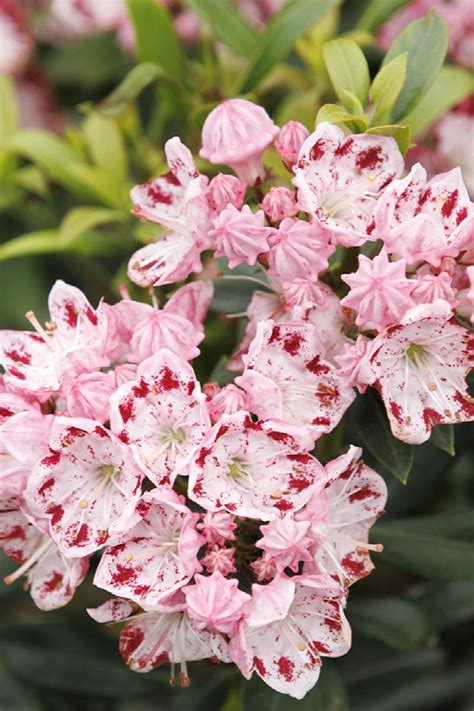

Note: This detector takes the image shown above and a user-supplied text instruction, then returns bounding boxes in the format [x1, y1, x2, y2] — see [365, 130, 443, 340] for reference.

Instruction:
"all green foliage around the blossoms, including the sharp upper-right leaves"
[0, 0, 474, 711]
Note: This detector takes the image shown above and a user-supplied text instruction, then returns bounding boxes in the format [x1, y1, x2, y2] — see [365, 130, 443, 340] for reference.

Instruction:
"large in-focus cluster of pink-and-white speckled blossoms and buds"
[0, 99, 474, 698]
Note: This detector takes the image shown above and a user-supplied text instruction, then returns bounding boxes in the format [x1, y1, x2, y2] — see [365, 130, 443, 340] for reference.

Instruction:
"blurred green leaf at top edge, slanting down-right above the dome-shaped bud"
[189, 0, 257, 57]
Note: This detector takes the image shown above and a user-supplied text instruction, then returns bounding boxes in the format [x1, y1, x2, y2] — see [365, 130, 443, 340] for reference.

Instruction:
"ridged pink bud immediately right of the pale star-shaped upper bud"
[268, 219, 334, 284]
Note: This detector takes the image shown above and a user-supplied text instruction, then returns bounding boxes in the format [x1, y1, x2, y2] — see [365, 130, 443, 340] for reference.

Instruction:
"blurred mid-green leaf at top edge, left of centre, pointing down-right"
[127, 0, 186, 81]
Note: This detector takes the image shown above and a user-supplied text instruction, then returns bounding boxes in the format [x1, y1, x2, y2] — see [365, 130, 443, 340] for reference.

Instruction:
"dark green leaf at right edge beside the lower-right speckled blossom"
[372, 511, 474, 582]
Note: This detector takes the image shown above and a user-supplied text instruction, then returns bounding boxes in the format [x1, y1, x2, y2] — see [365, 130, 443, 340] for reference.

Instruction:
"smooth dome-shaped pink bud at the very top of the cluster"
[199, 99, 279, 185]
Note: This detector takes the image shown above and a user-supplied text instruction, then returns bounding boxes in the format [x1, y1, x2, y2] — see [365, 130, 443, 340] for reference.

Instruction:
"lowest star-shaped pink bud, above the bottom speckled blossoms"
[183, 570, 250, 634]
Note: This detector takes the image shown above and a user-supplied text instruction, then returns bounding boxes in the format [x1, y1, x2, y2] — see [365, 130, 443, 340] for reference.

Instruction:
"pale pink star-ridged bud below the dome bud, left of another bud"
[209, 205, 271, 269]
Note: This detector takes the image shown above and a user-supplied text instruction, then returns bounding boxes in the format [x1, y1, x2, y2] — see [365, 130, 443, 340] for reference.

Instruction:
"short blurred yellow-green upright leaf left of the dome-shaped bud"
[83, 112, 128, 183]
